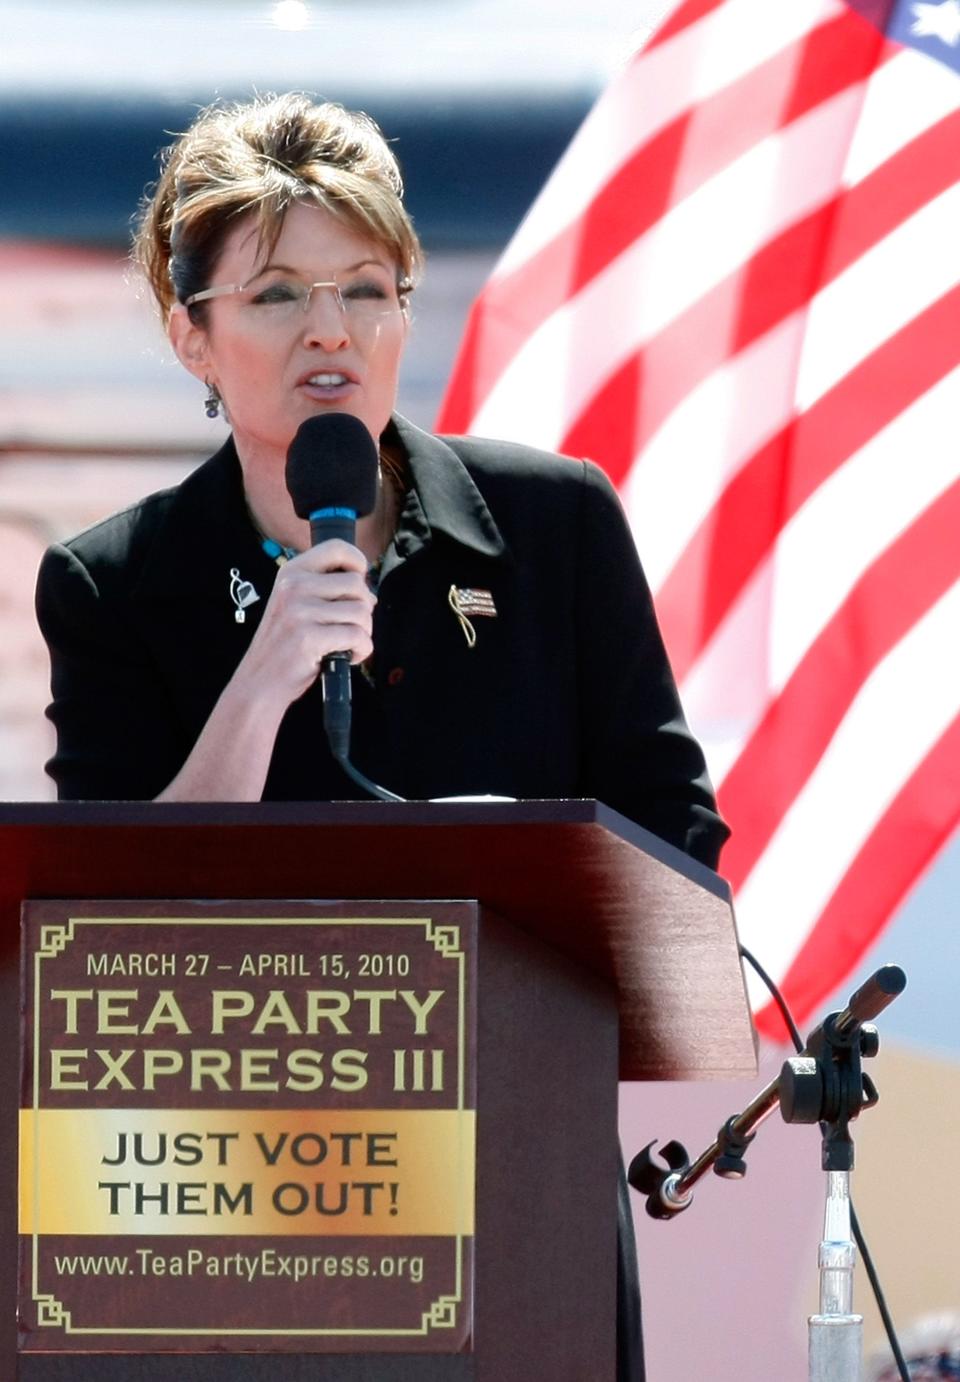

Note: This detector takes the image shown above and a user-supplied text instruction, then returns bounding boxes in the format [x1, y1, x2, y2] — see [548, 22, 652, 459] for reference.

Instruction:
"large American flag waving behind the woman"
[438, 0, 960, 1035]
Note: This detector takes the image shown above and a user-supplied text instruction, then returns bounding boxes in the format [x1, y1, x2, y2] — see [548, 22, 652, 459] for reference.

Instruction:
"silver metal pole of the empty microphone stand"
[808, 1171, 863, 1382]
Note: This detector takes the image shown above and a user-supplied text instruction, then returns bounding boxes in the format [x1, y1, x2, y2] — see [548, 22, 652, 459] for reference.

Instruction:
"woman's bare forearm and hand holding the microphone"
[157, 539, 377, 802]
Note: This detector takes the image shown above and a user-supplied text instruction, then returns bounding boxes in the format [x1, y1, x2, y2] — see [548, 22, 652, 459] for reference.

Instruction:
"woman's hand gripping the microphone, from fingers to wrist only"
[233, 538, 377, 710]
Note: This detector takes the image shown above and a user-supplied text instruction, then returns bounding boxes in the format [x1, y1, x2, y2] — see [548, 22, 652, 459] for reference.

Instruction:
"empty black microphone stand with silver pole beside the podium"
[627, 965, 906, 1382]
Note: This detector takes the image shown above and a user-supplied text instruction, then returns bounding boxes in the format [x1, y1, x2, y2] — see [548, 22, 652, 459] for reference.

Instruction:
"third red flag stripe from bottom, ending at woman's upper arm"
[656, 287, 960, 680]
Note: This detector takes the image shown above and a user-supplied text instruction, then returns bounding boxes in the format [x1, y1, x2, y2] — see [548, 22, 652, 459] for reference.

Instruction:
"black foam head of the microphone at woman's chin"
[286, 413, 378, 518]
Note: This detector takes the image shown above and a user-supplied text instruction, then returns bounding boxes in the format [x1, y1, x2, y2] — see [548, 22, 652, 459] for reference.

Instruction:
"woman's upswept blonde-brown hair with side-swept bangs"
[133, 94, 423, 322]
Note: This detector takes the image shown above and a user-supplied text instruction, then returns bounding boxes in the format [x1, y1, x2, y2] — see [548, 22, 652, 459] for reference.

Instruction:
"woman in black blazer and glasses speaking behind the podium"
[37, 95, 727, 867]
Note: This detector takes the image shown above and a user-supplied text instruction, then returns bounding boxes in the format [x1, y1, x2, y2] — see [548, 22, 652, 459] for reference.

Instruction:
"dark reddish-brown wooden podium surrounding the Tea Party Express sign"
[0, 800, 756, 1382]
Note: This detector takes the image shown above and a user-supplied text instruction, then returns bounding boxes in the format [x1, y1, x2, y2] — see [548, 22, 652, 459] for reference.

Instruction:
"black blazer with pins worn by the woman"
[37, 417, 727, 865]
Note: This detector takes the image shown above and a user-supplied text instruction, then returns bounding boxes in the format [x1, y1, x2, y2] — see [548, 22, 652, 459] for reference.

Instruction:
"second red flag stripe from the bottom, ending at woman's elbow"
[720, 480, 960, 889]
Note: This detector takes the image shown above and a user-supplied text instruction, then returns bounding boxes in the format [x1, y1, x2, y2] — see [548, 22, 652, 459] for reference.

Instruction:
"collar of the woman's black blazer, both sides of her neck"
[133, 415, 506, 598]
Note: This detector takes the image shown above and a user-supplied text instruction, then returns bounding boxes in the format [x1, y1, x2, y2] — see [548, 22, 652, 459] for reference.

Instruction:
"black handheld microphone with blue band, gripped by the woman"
[286, 413, 378, 763]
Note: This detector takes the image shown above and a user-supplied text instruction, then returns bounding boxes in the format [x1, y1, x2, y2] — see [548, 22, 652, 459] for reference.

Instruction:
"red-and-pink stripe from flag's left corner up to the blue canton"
[436, 15, 885, 431]
